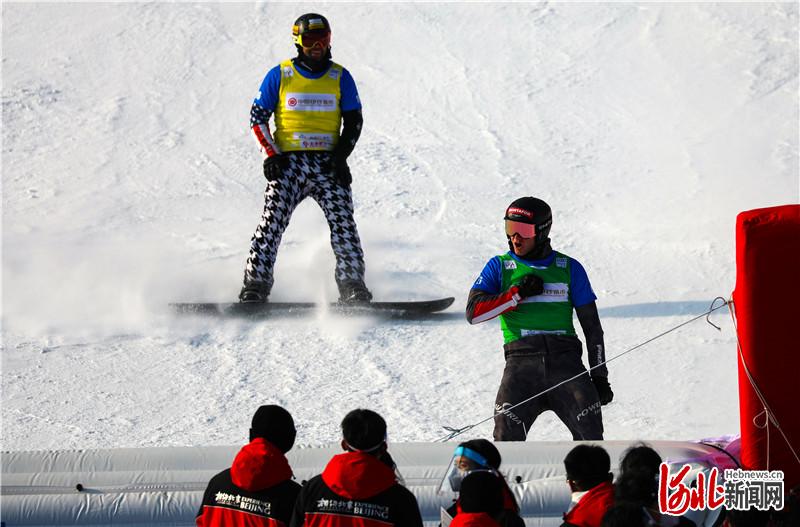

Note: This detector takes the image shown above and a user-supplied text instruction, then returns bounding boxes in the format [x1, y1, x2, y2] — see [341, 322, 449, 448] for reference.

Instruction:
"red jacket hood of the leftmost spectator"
[231, 437, 292, 492]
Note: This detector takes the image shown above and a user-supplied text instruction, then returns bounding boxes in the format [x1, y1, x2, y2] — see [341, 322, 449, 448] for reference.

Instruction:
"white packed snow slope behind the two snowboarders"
[2, 2, 800, 450]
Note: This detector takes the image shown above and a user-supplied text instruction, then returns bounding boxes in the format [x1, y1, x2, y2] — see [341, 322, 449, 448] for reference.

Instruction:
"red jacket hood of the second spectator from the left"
[322, 452, 396, 499]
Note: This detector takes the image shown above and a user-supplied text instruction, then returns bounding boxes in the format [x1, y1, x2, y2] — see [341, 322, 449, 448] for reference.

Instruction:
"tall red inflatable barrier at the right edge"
[733, 205, 800, 491]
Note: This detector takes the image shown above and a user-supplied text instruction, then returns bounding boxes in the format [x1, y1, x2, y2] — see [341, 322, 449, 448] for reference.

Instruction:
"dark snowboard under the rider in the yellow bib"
[169, 297, 455, 318]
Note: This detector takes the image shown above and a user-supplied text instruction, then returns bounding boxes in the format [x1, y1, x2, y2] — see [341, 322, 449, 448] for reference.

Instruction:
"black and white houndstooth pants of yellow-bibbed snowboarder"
[244, 152, 364, 290]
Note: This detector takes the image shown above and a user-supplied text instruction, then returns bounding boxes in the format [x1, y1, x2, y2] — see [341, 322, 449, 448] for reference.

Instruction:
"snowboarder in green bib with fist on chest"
[467, 197, 614, 441]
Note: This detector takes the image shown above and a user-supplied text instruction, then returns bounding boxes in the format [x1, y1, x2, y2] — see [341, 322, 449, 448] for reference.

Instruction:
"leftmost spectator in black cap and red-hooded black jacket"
[195, 405, 300, 527]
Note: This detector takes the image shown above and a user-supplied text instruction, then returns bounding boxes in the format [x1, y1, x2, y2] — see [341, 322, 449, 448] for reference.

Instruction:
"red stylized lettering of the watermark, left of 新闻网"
[658, 463, 725, 516]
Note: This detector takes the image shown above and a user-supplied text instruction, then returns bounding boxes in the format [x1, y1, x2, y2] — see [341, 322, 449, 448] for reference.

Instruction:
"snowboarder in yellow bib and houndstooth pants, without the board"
[239, 13, 372, 303]
